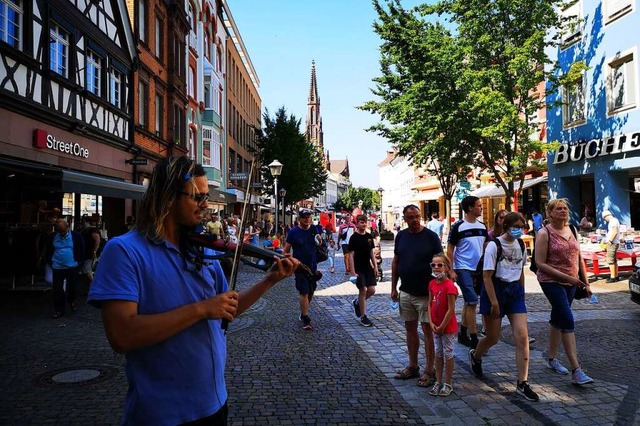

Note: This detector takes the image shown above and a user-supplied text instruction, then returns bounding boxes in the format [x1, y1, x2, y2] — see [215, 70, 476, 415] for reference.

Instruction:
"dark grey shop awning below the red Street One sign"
[62, 170, 147, 200]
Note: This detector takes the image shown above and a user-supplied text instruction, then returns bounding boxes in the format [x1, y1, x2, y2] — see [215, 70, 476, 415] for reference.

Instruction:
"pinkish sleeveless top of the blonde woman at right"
[537, 226, 580, 285]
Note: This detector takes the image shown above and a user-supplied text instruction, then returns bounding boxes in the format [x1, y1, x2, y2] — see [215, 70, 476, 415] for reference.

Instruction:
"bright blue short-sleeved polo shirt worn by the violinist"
[88, 231, 228, 425]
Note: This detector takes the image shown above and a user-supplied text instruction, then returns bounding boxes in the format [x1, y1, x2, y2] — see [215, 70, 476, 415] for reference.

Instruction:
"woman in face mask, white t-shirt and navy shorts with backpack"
[469, 212, 539, 401]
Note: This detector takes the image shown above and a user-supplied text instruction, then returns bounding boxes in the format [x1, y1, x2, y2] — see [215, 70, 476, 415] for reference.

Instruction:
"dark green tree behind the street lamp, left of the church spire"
[257, 107, 327, 201]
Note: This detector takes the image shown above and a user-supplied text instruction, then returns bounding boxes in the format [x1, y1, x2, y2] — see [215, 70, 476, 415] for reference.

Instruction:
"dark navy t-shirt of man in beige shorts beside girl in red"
[393, 228, 442, 297]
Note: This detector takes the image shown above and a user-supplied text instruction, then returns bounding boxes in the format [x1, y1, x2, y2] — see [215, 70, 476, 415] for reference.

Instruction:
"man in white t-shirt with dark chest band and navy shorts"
[447, 195, 487, 349]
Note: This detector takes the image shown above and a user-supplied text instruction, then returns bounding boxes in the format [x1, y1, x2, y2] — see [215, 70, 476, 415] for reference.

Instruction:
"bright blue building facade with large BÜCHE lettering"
[546, 0, 640, 229]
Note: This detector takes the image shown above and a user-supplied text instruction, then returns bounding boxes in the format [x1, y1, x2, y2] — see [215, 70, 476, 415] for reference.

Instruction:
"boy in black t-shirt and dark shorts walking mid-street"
[349, 214, 378, 327]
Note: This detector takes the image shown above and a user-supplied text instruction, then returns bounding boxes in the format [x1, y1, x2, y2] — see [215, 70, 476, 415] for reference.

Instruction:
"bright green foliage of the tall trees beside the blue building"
[361, 0, 561, 211]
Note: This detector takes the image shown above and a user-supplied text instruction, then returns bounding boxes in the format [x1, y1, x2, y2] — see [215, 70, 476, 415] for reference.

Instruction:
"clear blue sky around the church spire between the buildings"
[227, 0, 419, 189]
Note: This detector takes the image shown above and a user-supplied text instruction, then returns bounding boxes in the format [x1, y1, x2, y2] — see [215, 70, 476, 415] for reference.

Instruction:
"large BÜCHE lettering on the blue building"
[553, 132, 640, 164]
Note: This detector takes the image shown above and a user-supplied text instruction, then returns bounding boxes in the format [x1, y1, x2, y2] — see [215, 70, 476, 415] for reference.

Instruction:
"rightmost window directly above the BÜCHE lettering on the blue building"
[607, 54, 637, 114]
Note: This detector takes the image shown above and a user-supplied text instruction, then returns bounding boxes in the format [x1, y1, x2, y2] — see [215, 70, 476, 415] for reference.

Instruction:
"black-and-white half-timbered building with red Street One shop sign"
[0, 0, 143, 286]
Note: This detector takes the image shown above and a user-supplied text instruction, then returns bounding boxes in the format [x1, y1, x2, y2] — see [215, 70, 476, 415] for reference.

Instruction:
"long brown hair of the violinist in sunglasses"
[136, 156, 206, 241]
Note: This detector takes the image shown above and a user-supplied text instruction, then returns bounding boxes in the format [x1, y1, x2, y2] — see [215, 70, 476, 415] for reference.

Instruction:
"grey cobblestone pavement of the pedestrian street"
[0, 242, 640, 425]
